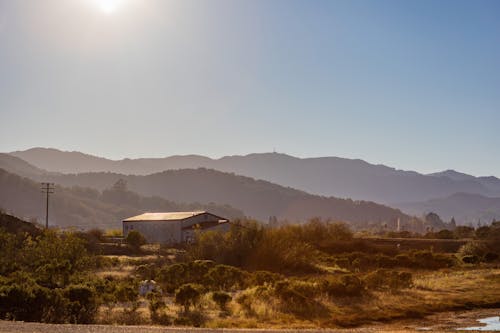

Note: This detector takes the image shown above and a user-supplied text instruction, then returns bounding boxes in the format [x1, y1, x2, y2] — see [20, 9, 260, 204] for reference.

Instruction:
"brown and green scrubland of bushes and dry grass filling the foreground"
[0, 213, 500, 328]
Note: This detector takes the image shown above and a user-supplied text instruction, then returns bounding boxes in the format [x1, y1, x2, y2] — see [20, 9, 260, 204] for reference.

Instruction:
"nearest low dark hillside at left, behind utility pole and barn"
[0, 169, 243, 229]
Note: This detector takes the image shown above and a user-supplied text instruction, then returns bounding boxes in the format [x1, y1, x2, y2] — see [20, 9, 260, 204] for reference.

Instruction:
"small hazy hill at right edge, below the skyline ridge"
[397, 193, 500, 224]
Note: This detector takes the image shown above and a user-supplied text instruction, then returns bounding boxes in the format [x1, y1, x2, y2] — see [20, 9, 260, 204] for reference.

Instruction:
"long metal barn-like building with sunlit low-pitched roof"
[123, 211, 229, 244]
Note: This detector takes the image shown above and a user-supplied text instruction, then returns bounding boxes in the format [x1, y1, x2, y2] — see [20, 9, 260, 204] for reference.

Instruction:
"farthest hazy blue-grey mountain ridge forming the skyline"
[11, 148, 500, 205]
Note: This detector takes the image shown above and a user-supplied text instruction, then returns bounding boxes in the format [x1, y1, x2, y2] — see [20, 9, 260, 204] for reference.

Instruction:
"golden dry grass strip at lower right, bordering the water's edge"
[206, 269, 500, 328]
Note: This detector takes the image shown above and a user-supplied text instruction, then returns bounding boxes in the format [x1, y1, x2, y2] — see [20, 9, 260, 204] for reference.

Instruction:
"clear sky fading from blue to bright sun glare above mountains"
[0, 0, 500, 177]
